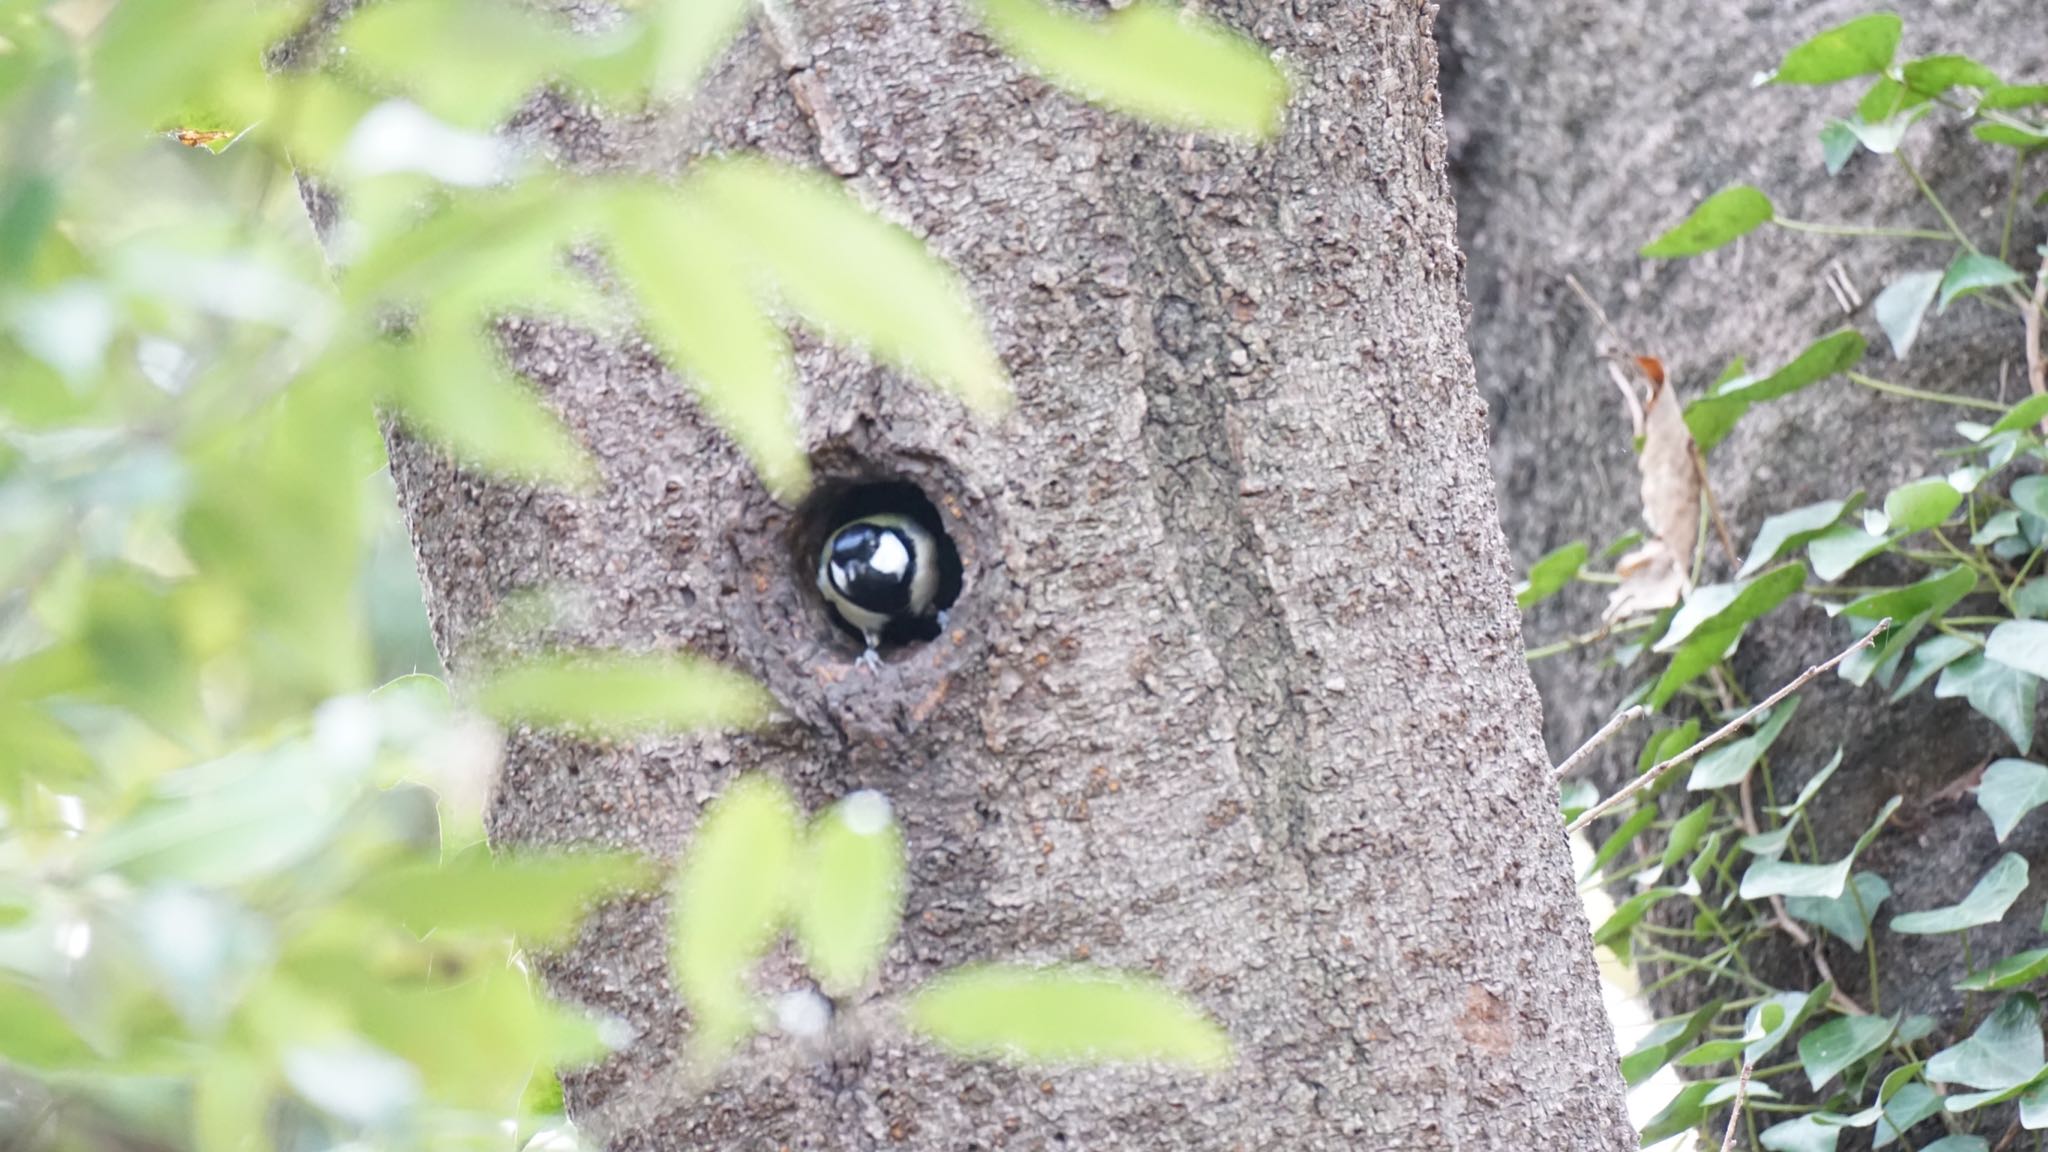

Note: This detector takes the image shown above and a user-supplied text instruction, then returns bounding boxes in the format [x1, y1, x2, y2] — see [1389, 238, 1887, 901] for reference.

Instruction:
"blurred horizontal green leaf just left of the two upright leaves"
[348, 847, 647, 945]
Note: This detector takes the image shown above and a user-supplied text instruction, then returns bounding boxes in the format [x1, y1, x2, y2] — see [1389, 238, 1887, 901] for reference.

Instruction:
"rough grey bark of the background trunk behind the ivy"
[1442, 0, 2048, 1021]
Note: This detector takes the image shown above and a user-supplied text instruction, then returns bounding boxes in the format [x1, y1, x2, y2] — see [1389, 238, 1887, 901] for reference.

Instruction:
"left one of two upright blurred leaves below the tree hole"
[670, 777, 801, 1056]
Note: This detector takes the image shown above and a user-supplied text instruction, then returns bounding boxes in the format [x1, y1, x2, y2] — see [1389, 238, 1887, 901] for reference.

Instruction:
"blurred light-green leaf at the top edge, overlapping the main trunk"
[977, 0, 1288, 139]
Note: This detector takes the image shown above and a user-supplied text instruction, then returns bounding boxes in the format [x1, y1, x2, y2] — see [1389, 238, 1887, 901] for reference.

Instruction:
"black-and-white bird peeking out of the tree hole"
[817, 512, 946, 668]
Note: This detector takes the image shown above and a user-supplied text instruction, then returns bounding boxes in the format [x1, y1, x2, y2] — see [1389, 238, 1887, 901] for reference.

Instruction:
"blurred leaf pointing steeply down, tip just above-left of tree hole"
[608, 186, 811, 500]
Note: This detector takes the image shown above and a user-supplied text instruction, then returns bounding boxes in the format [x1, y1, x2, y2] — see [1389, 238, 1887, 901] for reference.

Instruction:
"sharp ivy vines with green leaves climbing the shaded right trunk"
[1520, 14, 2048, 1152]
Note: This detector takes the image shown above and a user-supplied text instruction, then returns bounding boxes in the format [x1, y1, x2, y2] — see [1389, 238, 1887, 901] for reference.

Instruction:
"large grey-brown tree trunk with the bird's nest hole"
[380, 0, 1632, 1152]
